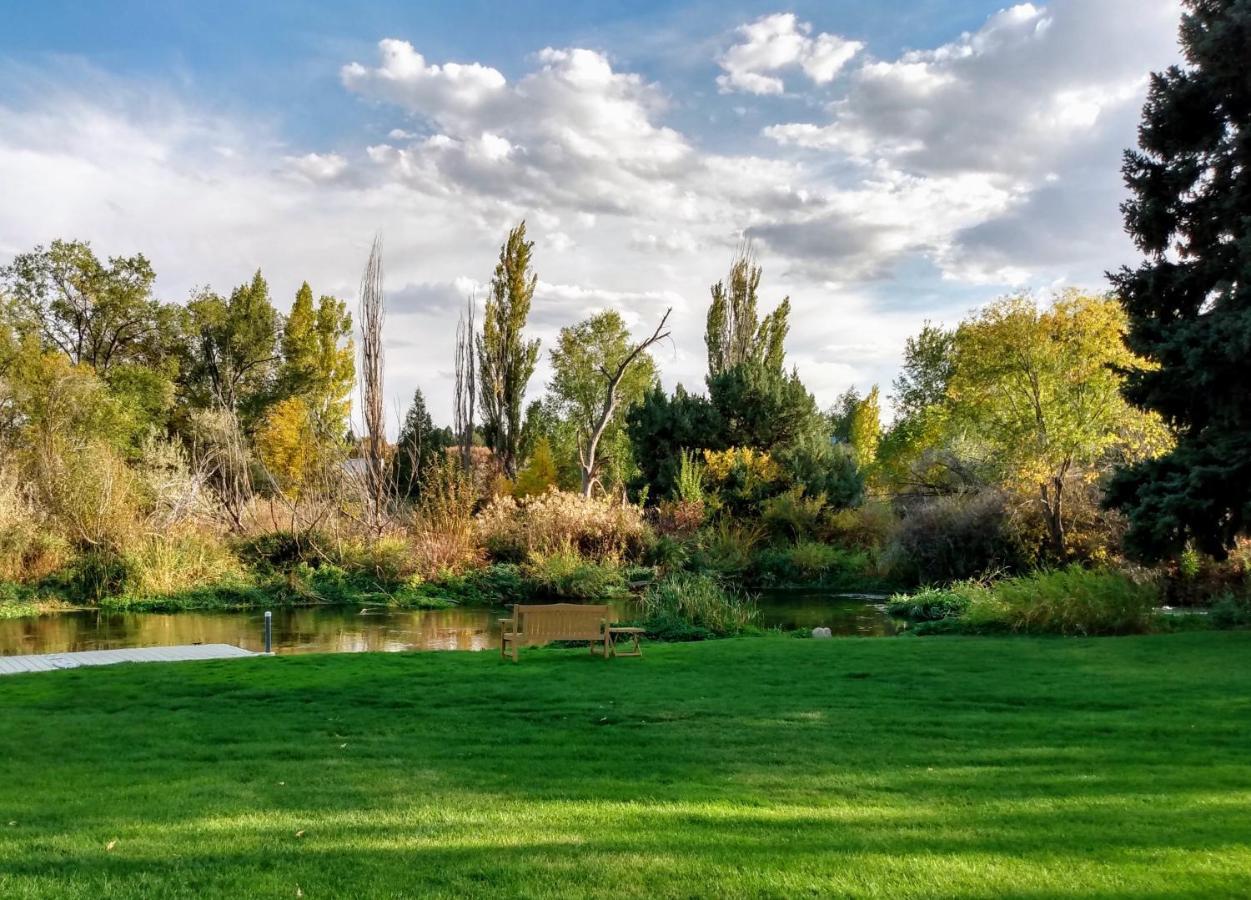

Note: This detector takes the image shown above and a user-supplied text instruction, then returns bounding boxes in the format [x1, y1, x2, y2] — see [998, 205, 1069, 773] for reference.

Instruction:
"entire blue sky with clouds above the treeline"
[0, 0, 1180, 430]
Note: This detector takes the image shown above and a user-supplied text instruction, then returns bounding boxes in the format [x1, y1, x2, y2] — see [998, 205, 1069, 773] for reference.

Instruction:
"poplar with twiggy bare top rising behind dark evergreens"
[704, 249, 791, 378]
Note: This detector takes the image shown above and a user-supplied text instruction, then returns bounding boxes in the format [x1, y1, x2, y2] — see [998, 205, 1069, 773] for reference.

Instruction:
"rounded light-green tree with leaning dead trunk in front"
[548, 310, 668, 496]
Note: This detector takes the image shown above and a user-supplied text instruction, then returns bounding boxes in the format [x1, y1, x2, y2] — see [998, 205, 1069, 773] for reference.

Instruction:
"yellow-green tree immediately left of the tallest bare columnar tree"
[278, 282, 357, 437]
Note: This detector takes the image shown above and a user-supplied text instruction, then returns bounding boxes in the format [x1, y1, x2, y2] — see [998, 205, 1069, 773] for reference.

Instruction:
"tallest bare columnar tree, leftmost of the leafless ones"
[359, 235, 392, 533]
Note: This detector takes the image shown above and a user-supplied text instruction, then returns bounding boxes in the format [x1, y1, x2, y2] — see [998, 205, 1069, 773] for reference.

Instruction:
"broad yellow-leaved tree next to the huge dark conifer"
[948, 292, 1166, 558]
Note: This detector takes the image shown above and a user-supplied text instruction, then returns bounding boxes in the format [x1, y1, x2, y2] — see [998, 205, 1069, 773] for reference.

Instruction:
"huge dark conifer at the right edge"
[1108, 0, 1251, 560]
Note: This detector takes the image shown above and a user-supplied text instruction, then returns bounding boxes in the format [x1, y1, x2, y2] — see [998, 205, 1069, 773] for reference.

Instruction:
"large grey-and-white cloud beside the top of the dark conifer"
[764, 0, 1178, 284]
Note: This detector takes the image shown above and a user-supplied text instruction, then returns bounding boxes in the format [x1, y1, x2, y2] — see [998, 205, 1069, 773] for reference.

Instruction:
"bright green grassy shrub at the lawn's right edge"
[965, 566, 1160, 635]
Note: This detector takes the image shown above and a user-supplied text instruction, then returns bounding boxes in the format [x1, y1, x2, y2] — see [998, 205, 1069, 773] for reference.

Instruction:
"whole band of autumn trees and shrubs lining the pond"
[0, 186, 1251, 640]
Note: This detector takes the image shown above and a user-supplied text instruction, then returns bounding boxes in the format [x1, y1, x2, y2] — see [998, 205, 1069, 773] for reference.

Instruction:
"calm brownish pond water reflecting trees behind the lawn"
[0, 592, 894, 656]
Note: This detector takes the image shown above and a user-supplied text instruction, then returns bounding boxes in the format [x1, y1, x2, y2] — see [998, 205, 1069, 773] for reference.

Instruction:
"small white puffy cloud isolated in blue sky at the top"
[717, 13, 864, 94]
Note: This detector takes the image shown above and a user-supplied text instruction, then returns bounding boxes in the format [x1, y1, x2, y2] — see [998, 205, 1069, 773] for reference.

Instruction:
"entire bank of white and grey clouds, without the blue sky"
[0, 0, 1176, 418]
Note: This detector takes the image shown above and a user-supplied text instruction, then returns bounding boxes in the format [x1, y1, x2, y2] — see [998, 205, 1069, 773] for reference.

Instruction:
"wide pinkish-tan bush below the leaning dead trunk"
[478, 489, 647, 562]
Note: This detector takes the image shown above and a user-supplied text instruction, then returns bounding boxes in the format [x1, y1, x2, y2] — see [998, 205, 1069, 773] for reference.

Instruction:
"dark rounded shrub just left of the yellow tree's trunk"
[886, 491, 1027, 585]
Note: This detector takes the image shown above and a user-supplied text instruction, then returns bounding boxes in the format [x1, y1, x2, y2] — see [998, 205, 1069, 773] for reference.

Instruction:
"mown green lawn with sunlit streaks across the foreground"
[0, 632, 1251, 900]
